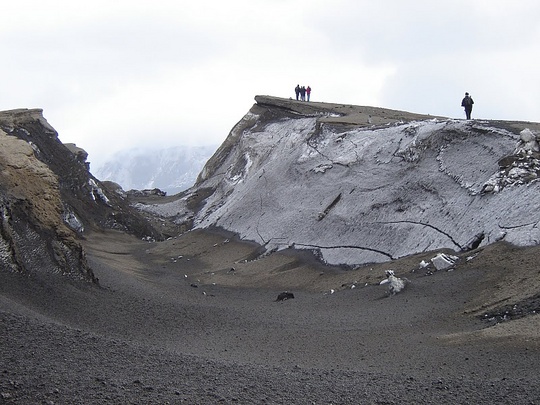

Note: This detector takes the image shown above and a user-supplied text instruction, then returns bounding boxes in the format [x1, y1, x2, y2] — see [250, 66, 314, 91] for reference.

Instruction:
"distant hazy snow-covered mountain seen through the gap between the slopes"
[93, 146, 217, 195]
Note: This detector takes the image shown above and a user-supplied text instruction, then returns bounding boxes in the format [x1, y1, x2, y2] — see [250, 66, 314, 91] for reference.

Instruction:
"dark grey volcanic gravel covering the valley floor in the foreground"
[0, 230, 540, 405]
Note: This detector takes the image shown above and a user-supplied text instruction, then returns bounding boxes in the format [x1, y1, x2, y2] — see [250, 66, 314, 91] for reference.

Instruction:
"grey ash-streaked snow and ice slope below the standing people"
[143, 96, 540, 265]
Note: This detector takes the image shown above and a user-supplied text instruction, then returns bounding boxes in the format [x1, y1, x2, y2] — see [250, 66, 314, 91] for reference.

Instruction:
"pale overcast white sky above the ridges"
[0, 0, 540, 167]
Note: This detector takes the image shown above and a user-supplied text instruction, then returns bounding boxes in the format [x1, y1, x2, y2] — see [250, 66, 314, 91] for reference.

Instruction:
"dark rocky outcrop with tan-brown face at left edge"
[0, 109, 161, 281]
